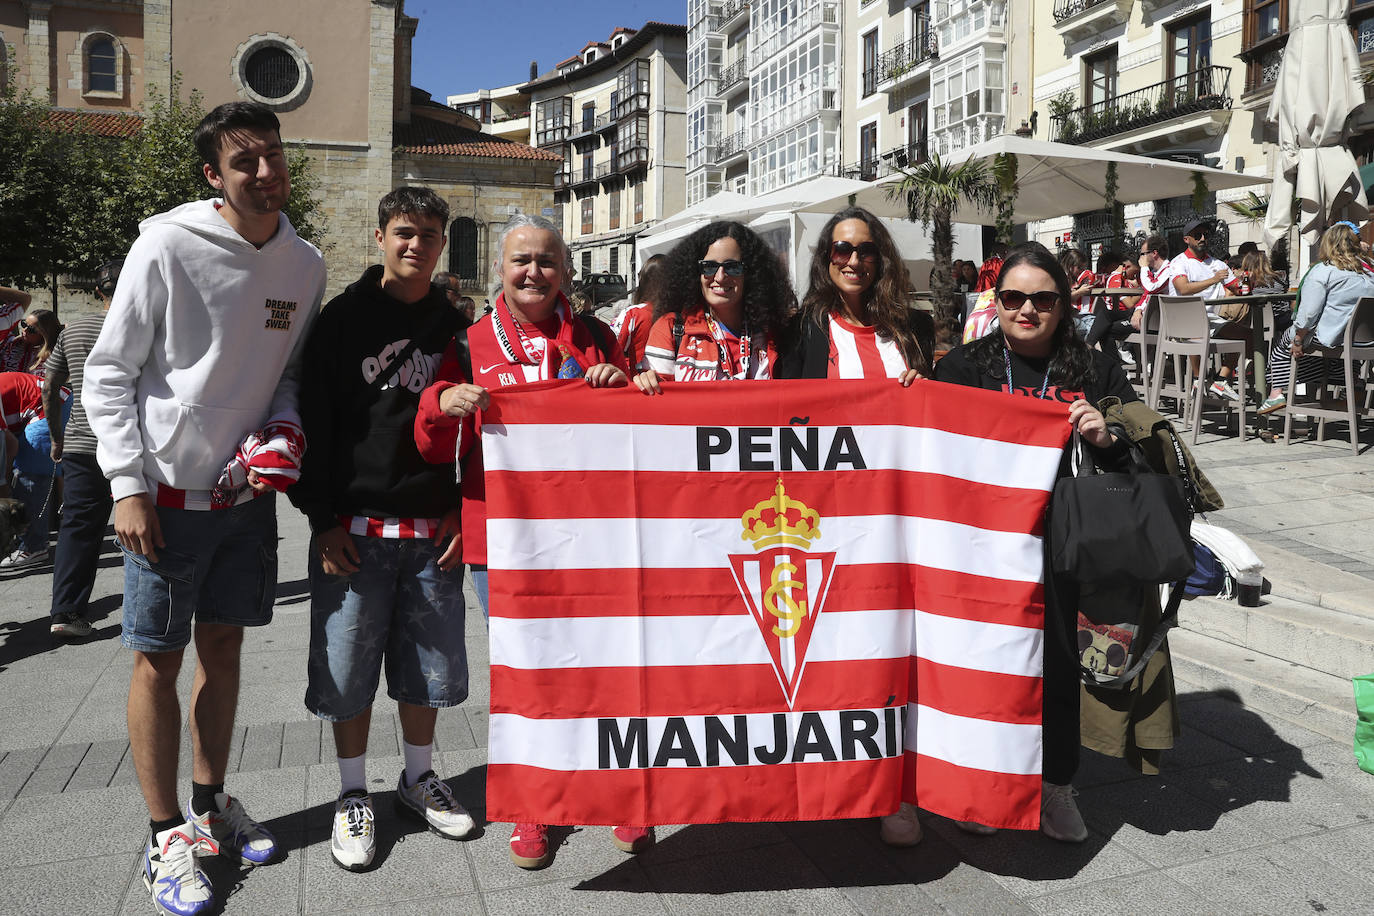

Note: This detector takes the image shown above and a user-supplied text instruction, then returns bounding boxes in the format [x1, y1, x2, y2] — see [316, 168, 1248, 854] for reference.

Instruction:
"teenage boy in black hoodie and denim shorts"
[289, 187, 473, 871]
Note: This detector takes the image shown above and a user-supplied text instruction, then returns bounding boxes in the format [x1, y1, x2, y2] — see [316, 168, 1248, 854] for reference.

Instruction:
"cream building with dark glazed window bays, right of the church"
[530, 22, 687, 275]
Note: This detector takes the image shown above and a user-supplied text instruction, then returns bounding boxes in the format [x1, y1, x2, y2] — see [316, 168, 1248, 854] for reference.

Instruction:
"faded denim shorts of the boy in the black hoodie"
[305, 536, 467, 722]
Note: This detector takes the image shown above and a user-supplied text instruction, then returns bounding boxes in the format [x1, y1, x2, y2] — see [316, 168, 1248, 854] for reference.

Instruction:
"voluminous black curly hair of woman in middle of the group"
[654, 222, 797, 341]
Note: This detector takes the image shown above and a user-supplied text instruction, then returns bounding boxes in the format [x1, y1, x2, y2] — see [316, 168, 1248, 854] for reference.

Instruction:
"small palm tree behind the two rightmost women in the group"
[892, 152, 998, 324]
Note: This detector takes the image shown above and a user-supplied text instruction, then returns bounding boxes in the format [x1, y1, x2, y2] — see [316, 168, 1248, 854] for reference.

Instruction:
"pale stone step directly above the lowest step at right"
[1179, 593, 1374, 678]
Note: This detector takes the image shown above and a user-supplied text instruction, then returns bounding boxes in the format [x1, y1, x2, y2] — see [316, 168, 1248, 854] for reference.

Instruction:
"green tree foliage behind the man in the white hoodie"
[0, 78, 324, 311]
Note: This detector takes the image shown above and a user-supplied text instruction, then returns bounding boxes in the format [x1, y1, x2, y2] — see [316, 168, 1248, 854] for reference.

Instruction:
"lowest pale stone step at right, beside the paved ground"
[1169, 628, 1355, 742]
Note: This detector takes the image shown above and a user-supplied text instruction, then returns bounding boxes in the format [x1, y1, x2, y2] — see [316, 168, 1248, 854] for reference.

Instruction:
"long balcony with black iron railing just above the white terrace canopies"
[1050, 66, 1231, 152]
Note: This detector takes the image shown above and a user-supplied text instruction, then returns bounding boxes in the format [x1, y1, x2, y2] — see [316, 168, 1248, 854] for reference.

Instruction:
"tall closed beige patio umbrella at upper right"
[1264, 0, 1369, 246]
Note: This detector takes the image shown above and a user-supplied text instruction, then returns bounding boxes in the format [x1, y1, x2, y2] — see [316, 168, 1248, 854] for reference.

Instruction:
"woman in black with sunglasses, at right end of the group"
[934, 243, 1137, 843]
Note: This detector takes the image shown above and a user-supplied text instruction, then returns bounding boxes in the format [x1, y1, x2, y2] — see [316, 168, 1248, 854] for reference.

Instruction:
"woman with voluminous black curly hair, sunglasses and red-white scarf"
[635, 222, 796, 394]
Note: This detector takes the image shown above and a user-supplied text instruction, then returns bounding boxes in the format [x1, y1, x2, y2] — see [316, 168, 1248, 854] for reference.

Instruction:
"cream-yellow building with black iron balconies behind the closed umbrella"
[1033, 0, 1374, 253]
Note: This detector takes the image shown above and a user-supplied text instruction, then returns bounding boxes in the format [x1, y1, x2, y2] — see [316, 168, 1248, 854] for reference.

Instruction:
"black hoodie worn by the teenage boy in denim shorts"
[287, 265, 460, 533]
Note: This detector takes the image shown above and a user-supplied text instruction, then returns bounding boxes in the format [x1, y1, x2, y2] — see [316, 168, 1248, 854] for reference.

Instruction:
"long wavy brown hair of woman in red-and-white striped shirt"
[801, 207, 930, 375]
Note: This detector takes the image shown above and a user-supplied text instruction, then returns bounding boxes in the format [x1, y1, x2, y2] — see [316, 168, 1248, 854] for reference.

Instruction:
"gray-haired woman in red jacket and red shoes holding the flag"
[415, 214, 632, 868]
